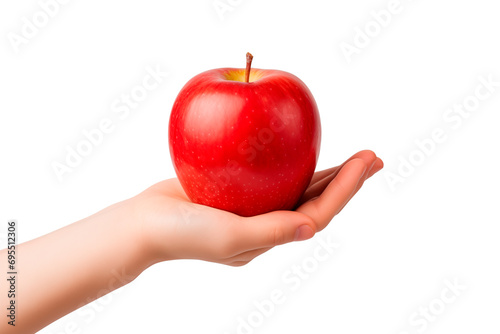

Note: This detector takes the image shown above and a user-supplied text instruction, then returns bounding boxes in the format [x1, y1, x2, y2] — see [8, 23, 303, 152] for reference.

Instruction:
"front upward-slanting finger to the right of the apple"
[297, 158, 367, 231]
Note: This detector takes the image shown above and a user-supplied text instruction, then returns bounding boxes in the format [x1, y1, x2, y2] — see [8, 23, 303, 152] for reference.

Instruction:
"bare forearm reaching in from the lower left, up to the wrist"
[0, 201, 149, 333]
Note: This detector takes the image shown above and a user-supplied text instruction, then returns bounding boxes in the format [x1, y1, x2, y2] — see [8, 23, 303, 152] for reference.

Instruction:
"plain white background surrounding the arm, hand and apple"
[0, 0, 500, 334]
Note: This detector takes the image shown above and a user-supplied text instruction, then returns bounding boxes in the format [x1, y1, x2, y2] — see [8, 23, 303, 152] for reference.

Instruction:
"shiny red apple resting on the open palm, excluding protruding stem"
[169, 68, 321, 216]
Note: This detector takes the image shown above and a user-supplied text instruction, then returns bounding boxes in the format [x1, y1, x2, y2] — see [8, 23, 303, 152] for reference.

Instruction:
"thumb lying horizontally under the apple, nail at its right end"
[235, 211, 316, 253]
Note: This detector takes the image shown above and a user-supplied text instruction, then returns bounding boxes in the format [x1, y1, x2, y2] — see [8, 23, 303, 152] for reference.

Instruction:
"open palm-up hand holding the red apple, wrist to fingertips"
[132, 151, 383, 266]
